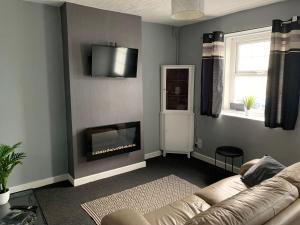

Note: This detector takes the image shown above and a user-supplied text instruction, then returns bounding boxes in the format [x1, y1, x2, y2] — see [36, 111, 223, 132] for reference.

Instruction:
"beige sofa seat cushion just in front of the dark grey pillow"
[195, 175, 247, 205]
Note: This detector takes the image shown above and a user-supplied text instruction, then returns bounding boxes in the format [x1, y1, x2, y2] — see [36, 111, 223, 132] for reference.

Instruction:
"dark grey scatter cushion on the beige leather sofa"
[242, 156, 285, 187]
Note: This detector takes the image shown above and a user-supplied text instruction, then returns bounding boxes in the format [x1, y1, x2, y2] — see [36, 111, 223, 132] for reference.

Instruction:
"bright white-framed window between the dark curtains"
[223, 28, 271, 120]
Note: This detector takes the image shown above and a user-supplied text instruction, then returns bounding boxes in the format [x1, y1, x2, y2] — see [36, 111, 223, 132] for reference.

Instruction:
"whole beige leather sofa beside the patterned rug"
[102, 160, 300, 225]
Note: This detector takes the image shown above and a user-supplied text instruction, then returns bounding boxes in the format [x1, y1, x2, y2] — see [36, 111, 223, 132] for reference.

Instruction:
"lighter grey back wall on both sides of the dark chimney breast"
[0, 0, 175, 187]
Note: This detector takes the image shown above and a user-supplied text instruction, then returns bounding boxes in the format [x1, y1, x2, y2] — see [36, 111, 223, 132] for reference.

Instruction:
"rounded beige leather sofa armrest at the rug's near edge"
[101, 209, 150, 225]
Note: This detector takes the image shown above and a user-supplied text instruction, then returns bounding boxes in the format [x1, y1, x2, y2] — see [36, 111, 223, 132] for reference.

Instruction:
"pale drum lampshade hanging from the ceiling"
[172, 0, 204, 20]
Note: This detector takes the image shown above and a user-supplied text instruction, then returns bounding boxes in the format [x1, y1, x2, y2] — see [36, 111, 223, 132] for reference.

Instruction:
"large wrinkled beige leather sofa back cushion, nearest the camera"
[185, 177, 299, 225]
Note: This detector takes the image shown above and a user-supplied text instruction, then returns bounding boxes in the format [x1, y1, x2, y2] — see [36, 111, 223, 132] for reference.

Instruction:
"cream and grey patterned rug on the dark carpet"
[81, 175, 200, 225]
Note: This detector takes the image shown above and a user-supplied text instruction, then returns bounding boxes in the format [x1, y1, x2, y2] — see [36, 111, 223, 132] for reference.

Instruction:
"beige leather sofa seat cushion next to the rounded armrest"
[144, 195, 210, 225]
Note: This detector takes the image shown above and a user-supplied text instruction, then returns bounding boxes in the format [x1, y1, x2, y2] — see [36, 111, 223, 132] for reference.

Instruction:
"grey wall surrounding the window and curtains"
[180, 0, 300, 164]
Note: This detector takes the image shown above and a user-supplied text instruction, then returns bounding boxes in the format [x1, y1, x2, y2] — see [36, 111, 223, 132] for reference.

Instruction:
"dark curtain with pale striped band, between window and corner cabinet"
[201, 31, 224, 117]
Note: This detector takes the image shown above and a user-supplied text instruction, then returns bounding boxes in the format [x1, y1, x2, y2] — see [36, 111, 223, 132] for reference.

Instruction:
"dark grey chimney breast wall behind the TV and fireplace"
[61, 3, 144, 178]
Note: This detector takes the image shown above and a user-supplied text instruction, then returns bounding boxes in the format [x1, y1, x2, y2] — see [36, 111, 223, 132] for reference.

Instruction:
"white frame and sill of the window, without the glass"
[222, 27, 272, 121]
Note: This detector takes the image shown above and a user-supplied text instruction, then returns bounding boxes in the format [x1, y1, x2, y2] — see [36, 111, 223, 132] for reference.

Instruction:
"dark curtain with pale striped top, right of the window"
[265, 17, 300, 130]
